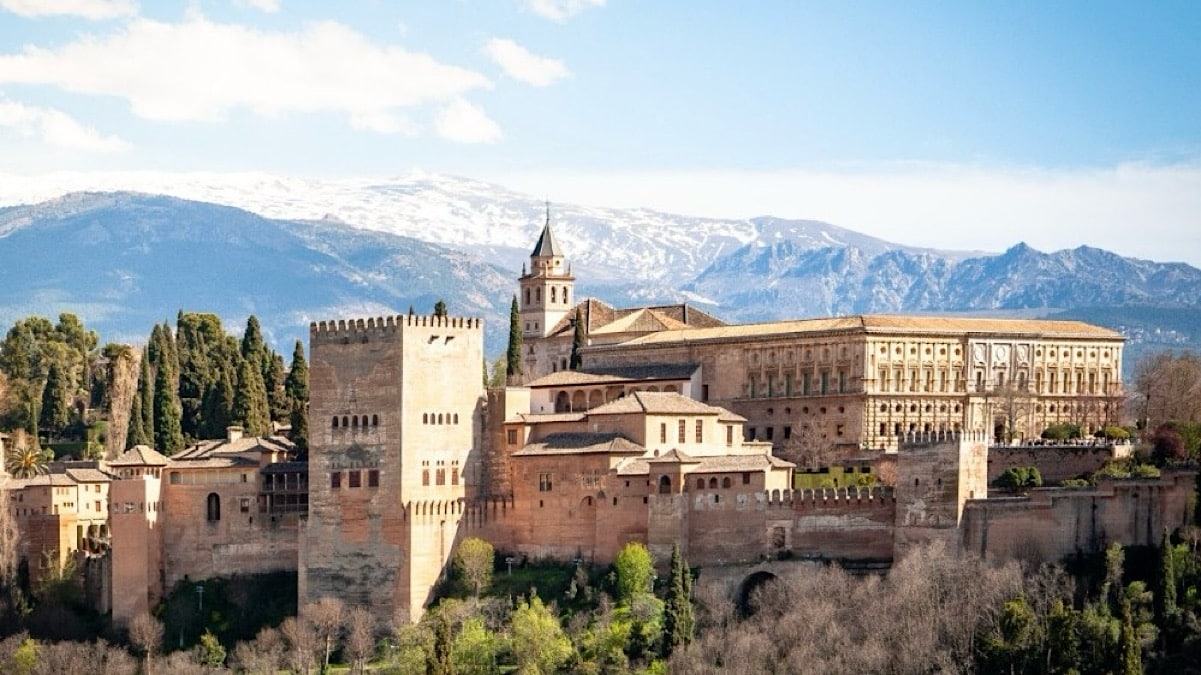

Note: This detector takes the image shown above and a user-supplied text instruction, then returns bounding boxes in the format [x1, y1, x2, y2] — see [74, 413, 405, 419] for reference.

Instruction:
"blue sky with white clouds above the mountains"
[0, 0, 1201, 267]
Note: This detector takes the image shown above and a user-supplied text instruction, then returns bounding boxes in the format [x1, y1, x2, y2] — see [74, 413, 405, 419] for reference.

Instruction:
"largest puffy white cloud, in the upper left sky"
[0, 12, 491, 132]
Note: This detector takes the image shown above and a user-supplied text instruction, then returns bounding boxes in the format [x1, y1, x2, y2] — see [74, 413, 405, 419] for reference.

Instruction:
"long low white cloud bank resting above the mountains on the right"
[492, 162, 1201, 267]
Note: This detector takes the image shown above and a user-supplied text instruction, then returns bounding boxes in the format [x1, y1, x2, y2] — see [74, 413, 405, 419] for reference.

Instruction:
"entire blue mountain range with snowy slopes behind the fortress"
[0, 169, 1201, 365]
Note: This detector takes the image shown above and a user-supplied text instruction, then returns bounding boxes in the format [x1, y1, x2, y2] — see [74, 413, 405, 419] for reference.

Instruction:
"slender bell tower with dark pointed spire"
[519, 203, 575, 340]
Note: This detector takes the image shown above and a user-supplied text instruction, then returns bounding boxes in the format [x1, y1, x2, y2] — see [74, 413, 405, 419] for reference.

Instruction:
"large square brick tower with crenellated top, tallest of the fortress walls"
[299, 315, 484, 620]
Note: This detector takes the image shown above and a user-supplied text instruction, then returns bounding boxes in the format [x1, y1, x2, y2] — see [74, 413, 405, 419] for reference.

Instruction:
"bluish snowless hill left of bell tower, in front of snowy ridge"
[0, 187, 512, 350]
